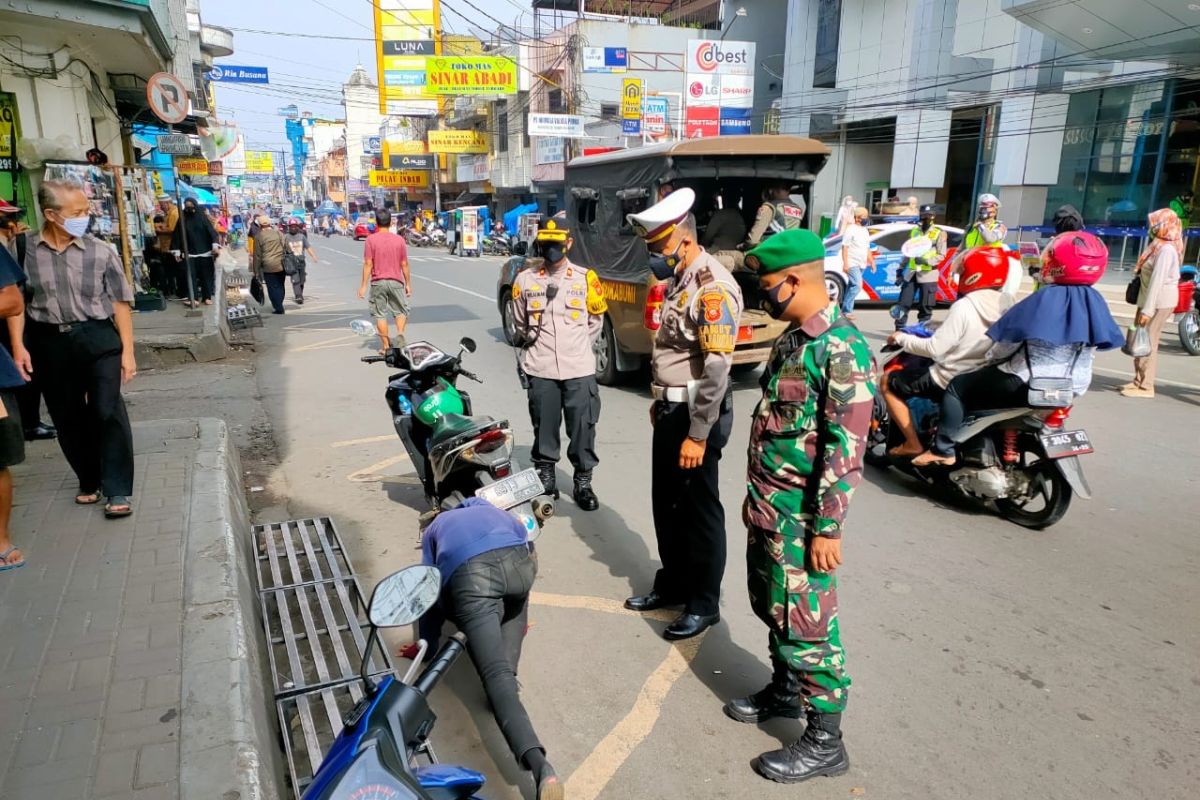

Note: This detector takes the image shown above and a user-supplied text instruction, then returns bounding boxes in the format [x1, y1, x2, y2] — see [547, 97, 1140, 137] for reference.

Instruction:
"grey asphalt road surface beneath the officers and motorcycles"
[248, 239, 1200, 800]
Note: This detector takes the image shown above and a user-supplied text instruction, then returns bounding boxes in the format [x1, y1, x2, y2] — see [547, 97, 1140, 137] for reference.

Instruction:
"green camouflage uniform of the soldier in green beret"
[744, 305, 876, 714]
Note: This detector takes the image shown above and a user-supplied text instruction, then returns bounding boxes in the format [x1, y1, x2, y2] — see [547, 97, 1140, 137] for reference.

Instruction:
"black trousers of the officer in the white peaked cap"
[650, 402, 733, 615]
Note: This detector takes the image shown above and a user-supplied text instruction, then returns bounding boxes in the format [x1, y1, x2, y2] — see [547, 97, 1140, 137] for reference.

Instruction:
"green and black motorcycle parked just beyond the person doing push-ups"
[350, 328, 554, 533]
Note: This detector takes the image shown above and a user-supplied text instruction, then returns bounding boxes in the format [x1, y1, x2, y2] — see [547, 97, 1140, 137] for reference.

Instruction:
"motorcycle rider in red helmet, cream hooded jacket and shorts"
[881, 247, 1012, 458]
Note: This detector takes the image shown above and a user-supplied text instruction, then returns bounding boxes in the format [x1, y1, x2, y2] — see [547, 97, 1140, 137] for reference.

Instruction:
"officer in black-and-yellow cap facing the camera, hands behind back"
[512, 219, 608, 511]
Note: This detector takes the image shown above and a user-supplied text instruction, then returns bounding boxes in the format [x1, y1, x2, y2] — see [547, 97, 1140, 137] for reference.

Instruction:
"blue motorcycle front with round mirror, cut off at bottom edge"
[301, 566, 485, 800]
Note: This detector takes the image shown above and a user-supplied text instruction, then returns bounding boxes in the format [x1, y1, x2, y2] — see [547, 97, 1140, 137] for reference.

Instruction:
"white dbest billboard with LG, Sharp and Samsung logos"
[683, 38, 755, 138]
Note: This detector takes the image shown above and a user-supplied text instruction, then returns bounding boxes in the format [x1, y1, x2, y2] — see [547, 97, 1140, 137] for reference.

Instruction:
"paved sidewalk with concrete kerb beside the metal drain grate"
[0, 420, 281, 800]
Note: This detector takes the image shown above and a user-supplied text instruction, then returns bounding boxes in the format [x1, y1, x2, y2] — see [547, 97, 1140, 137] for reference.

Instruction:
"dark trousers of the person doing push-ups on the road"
[442, 545, 542, 763]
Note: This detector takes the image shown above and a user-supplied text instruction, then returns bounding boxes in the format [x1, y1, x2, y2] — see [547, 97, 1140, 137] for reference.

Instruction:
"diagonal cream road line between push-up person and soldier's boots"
[565, 634, 704, 800]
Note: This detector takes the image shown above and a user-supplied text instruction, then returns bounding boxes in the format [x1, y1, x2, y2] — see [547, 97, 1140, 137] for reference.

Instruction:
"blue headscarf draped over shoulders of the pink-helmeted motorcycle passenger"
[988, 284, 1124, 350]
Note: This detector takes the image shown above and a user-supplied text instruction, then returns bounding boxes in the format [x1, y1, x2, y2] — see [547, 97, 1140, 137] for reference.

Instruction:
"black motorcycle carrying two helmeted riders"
[865, 325, 1093, 529]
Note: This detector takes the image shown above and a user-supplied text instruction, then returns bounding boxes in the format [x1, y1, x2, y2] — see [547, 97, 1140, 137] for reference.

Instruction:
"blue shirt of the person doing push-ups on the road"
[421, 498, 527, 587]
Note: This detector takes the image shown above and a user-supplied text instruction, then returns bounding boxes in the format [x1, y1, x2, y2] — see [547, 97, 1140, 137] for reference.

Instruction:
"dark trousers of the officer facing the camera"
[529, 375, 600, 473]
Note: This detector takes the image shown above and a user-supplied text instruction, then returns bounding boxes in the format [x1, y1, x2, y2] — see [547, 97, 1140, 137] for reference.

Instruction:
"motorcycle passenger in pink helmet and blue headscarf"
[912, 230, 1124, 467]
